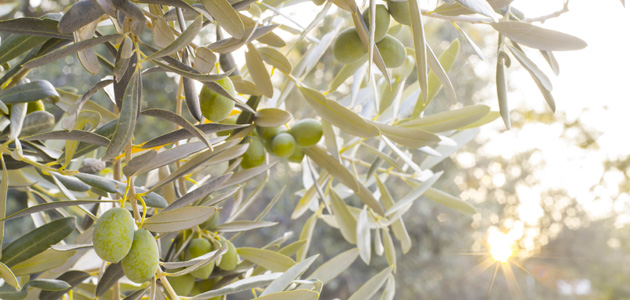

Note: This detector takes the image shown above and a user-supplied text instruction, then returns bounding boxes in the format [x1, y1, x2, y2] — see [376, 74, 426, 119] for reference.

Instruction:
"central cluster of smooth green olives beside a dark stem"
[241, 119, 323, 169]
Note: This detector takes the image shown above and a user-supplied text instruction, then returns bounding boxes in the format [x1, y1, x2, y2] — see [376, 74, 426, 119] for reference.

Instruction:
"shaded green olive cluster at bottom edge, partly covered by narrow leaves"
[168, 238, 238, 296]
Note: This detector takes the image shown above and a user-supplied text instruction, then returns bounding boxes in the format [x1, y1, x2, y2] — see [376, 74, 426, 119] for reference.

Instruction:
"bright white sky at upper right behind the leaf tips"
[463, 0, 630, 252]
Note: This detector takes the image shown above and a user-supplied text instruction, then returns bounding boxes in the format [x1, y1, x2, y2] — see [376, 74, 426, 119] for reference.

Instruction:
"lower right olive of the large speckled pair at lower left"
[122, 228, 160, 283]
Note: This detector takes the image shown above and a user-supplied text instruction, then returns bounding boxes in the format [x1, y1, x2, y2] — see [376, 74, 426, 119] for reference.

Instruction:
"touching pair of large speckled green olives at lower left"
[92, 207, 159, 283]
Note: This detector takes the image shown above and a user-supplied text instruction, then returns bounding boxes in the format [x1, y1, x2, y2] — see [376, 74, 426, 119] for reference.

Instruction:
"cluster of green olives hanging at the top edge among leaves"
[333, 1, 409, 68]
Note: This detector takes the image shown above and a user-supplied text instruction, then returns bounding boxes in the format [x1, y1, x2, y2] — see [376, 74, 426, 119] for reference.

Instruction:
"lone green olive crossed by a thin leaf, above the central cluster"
[199, 77, 236, 122]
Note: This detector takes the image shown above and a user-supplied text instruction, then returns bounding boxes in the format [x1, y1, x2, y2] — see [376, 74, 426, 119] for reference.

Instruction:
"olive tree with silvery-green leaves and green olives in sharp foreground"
[0, 0, 586, 299]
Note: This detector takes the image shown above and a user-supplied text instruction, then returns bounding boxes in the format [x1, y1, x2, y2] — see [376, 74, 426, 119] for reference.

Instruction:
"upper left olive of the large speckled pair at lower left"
[92, 207, 135, 263]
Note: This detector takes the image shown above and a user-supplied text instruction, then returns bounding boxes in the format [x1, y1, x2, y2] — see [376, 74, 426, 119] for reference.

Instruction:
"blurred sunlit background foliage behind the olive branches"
[0, 0, 630, 299]
